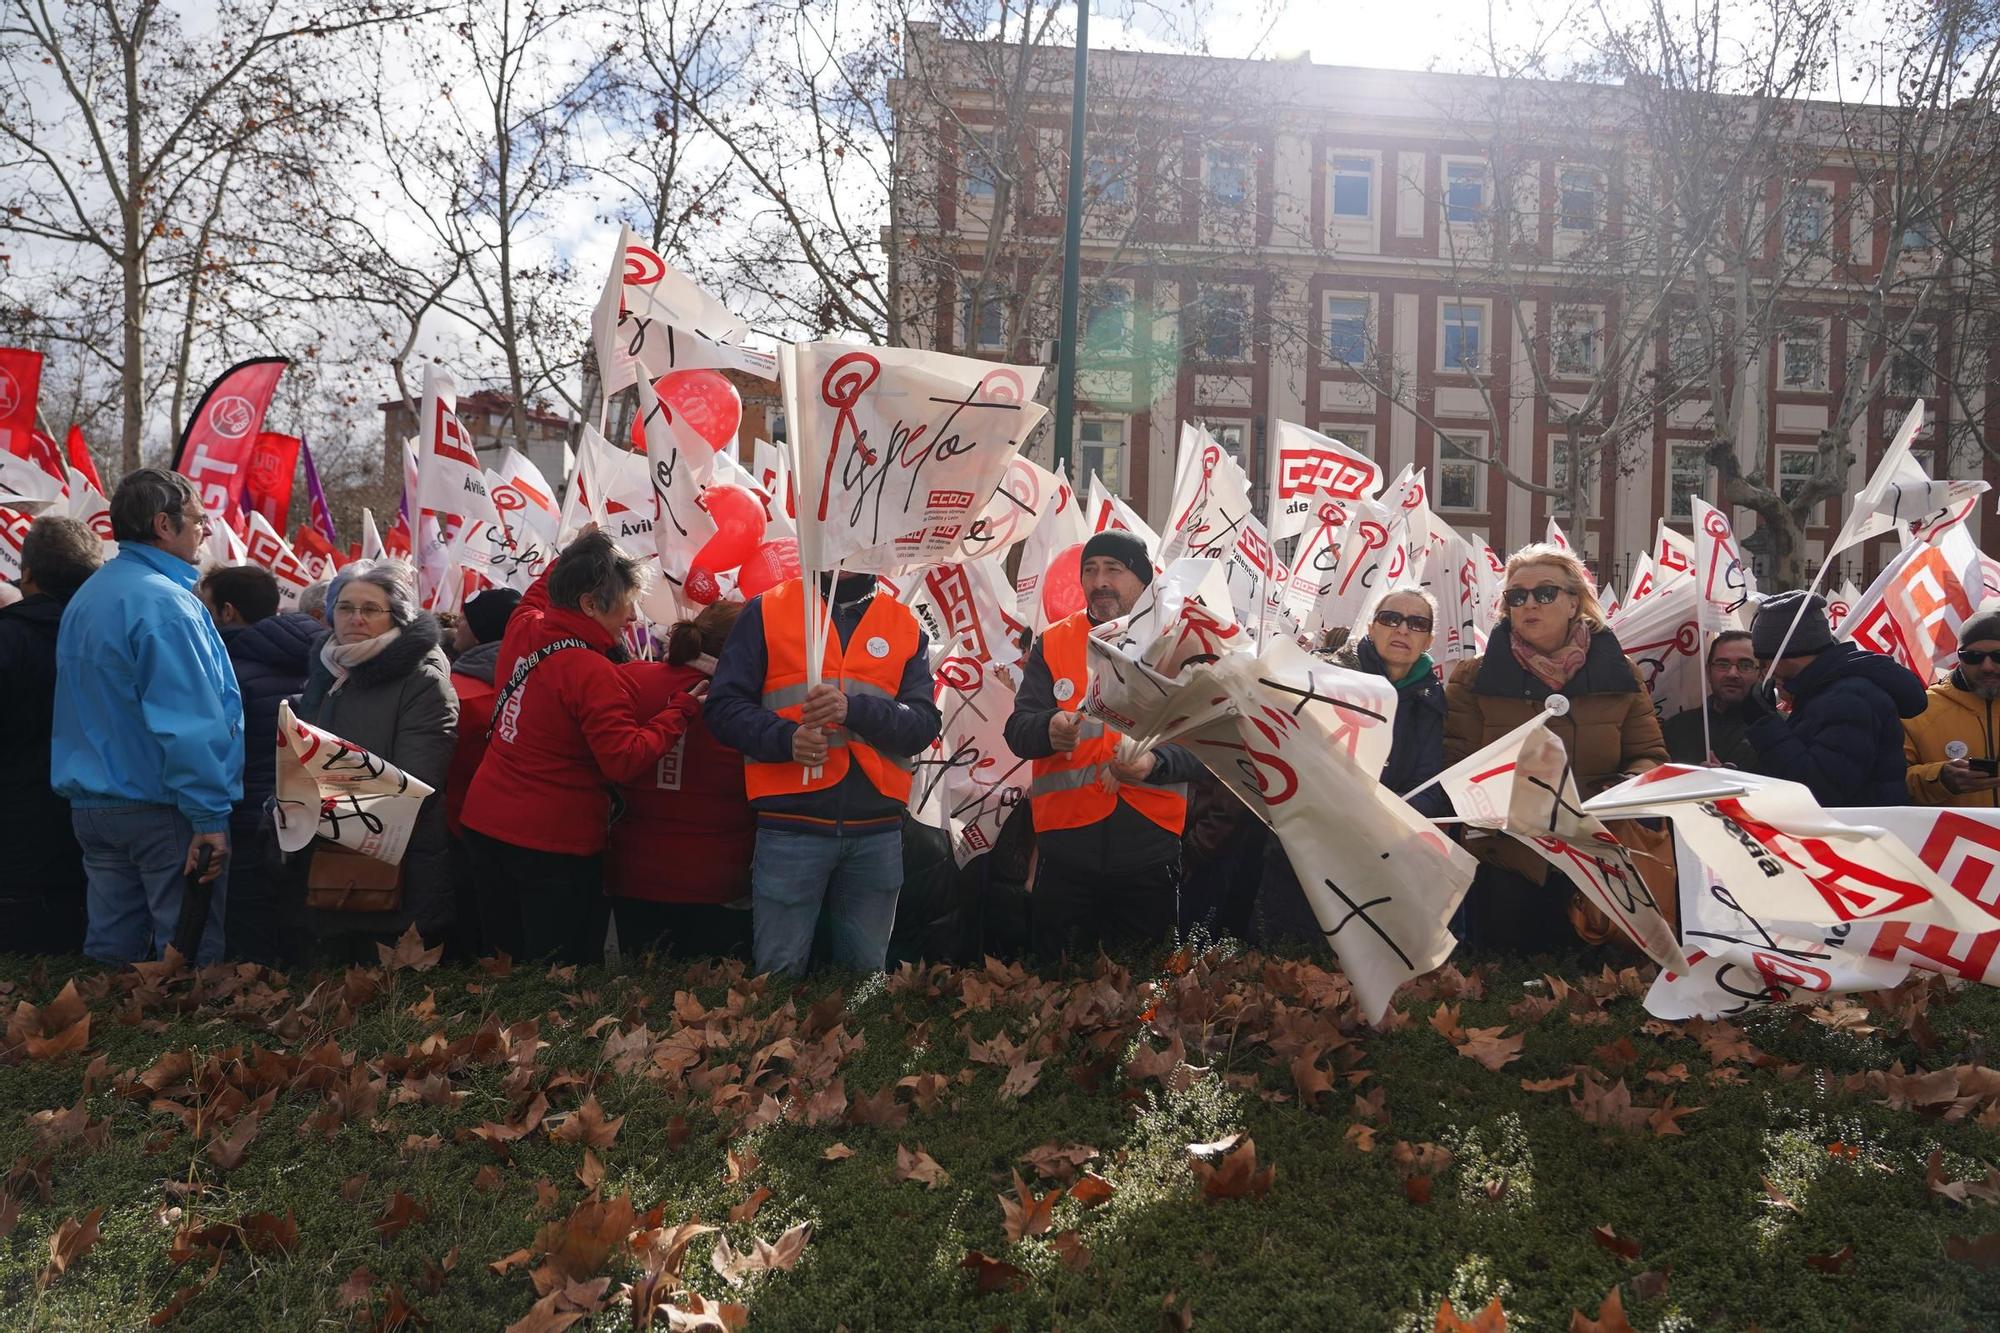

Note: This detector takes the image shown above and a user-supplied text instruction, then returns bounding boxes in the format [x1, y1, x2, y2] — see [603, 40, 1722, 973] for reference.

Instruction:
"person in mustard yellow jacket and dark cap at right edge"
[1902, 610, 2000, 809]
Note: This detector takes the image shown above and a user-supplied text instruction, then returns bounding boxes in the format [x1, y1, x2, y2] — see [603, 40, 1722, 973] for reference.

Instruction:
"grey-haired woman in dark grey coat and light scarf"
[294, 560, 458, 963]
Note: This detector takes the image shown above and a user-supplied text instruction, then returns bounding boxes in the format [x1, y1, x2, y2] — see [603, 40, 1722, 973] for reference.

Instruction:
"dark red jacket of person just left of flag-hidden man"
[604, 662, 756, 903]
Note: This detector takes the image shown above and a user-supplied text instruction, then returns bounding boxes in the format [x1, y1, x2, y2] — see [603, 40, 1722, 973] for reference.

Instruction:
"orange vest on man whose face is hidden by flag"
[744, 578, 922, 801]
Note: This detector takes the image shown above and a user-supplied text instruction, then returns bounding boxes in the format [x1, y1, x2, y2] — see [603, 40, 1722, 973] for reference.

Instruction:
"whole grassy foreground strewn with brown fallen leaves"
[0, 941, 2000, 1331]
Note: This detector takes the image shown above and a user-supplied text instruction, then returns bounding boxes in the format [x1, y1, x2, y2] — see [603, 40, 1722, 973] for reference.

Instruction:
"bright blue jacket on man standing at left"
[50, 542, 244, 833]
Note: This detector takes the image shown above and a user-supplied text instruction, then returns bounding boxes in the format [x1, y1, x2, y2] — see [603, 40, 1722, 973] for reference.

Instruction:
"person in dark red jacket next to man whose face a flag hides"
[604, 602, 756, 963]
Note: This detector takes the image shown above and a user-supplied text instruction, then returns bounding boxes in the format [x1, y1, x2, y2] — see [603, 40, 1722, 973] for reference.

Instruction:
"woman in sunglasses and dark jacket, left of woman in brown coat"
[1252, 588, 1452, 949]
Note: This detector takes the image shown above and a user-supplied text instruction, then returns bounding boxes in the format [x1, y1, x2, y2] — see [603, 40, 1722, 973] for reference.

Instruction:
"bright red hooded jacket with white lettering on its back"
[464, 574, 702, 857]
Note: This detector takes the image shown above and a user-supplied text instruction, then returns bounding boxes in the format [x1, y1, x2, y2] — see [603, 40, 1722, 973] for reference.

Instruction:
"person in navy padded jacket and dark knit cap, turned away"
[1746, 590, 1926, 809]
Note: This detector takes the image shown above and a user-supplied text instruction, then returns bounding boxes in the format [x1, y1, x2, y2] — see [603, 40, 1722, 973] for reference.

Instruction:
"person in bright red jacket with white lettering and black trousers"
[462, 528, 702, 963]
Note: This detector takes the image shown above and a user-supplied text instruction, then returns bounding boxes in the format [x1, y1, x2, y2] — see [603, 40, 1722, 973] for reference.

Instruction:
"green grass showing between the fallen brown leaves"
[0, 940, 2000, 1333]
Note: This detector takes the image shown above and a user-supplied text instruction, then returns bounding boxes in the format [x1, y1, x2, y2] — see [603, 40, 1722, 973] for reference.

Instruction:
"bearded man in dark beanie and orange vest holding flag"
[1006, 530, 1202, 961]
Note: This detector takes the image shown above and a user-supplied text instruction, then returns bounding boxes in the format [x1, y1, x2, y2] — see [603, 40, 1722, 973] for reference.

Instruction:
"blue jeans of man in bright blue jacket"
[70, 805, 230, 967]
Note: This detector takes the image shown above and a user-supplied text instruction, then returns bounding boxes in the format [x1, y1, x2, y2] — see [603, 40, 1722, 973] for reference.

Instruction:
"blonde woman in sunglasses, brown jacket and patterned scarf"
[1444, 542, 1666, 953]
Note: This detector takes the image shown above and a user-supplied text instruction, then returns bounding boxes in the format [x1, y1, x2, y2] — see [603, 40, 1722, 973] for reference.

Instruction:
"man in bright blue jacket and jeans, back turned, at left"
[50, 468, 244, 963]
